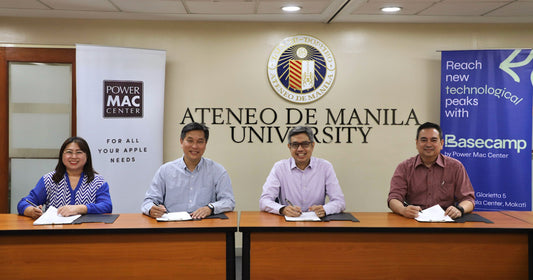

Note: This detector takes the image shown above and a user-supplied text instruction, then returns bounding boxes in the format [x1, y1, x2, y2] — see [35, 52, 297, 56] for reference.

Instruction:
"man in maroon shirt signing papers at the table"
[387, 122, 475, 219]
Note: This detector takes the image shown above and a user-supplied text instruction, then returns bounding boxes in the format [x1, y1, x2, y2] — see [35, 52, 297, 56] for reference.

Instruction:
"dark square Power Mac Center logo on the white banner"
[104, 81, 143, 118]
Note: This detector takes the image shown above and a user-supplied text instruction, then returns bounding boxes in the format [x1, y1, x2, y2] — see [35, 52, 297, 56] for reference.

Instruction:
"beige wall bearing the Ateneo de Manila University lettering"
[0, 18, 533, 214]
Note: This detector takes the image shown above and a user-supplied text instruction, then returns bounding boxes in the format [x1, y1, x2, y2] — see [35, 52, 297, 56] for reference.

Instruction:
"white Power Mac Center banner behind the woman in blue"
[76, 45, 166, 213]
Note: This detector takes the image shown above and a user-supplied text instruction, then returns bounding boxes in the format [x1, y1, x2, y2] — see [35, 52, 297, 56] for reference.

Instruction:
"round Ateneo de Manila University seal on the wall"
[268, 35, 335, 103]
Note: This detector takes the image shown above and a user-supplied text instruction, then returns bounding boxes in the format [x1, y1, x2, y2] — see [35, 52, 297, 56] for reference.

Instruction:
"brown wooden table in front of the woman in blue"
[0, 212, 237, 280]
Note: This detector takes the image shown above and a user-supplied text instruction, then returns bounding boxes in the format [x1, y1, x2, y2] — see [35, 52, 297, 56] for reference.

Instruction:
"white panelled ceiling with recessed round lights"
[0, 0, 533, 23]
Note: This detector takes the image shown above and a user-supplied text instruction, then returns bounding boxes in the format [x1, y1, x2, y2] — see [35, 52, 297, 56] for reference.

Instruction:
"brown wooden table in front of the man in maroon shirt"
[239, 211, 533, 279]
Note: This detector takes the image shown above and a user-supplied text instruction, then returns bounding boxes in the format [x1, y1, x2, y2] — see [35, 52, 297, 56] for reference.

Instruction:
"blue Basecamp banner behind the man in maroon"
[441, 49, 533, 211]
